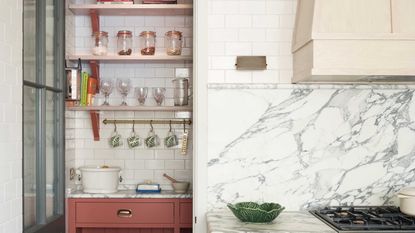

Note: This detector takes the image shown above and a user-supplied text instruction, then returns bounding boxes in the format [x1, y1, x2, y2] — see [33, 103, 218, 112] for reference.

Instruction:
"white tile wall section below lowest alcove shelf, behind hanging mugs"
[66, 111, 192, 190]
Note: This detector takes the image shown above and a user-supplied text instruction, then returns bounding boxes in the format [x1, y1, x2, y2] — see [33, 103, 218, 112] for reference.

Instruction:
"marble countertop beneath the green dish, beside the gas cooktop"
[207, 209, 336, 233]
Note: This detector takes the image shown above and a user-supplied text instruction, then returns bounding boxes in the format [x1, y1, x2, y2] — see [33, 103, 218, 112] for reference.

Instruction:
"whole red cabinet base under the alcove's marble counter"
[67, 198, 192, 233]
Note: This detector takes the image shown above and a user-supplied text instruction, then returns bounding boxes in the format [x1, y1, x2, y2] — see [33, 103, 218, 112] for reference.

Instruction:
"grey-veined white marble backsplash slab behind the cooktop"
[208, 87, 415, 210]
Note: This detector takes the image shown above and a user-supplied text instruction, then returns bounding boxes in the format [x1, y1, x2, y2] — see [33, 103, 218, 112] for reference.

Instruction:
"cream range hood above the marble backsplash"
[292, 0, 415, 83]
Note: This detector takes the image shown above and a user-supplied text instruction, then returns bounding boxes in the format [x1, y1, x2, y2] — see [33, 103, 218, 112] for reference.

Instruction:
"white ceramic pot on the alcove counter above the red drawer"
[79, 167, 121, 193]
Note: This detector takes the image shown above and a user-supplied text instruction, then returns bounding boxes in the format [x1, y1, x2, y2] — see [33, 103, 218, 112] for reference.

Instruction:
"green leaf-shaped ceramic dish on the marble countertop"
[228, 202, 285, 223]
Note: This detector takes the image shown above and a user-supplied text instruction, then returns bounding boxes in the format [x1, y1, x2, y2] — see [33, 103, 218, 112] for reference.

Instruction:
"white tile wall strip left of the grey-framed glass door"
[0, 0, 23, 233]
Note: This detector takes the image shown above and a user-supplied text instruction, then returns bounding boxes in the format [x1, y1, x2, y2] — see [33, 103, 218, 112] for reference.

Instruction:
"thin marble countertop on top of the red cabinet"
[66, 189, 192, 198]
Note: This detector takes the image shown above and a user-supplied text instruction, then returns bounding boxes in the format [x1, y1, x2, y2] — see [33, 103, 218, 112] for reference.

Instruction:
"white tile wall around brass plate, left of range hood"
[208, 0, 296, 83]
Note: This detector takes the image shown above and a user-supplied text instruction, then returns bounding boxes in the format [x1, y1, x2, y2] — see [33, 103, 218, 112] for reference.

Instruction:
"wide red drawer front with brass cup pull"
[76, 202, 174, 224]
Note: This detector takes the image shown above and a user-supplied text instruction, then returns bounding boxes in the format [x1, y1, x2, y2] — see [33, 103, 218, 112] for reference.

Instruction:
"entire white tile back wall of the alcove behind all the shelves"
[66, 0, 193, 190]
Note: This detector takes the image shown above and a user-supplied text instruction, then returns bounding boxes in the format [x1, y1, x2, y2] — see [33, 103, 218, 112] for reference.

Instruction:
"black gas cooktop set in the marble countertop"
[310, 206, 415, 233]
